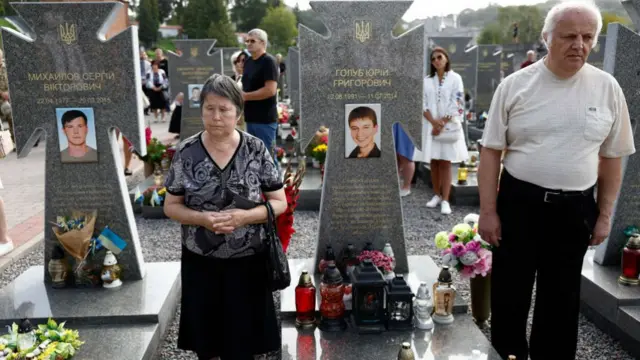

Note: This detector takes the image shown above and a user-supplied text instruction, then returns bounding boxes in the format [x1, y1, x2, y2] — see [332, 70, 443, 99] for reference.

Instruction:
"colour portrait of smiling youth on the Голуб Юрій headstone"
[344, 104, 382, 159]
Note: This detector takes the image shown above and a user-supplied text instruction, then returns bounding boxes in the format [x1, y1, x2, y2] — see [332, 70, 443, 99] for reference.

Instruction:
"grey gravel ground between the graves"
[0, 177, 633, 360]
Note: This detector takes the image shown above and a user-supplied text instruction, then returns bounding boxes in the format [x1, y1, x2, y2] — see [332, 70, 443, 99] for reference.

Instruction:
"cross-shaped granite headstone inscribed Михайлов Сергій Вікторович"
[3, 2, 146, 281]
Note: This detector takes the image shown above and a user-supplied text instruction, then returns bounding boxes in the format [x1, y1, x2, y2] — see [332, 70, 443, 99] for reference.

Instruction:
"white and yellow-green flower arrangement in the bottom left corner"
[0, 319, 84, 360]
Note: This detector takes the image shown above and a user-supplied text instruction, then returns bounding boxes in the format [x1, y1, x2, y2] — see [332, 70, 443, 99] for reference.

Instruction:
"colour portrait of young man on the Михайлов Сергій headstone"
[56, 108, 98, 163]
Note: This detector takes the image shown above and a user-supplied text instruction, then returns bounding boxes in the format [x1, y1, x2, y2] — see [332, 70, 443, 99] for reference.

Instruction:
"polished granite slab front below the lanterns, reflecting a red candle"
[282, 314, 501, 360]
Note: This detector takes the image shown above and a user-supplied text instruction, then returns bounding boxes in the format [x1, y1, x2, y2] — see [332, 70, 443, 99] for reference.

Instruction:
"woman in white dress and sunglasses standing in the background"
[422, 47, 469, 215]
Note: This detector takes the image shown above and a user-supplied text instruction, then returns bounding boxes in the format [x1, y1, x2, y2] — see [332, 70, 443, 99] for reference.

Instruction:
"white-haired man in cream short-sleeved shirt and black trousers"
[479, 2, 635, 360]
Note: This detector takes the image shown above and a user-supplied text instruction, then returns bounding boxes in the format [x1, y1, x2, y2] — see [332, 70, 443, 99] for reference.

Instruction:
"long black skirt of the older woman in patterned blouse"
[178, 246, 282, 360]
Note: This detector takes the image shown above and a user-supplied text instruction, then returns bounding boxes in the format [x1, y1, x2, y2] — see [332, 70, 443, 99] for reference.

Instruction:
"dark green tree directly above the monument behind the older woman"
[183, 0, 238, 47]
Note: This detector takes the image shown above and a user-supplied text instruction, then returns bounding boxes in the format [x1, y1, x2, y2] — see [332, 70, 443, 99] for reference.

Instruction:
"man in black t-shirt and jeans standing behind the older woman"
[242, 29, 278, 156]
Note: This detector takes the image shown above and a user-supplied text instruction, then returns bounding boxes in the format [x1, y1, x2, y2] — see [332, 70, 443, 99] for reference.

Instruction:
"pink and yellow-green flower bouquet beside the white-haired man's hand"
[435, 224, 493, 278]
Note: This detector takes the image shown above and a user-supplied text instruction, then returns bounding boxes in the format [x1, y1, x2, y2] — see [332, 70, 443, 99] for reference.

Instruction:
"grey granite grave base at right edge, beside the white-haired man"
[580, 250, 640, 358]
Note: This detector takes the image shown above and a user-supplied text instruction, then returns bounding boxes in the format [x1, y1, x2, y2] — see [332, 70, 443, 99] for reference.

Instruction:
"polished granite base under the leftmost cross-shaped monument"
[0, 262, 180, 326]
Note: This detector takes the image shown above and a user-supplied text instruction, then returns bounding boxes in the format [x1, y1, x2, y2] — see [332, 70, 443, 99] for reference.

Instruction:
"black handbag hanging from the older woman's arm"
[264, 201, 291, 291]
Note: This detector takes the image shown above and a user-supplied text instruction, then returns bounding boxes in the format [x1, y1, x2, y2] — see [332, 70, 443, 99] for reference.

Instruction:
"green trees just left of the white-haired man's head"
[478, 5, 544, 44]
